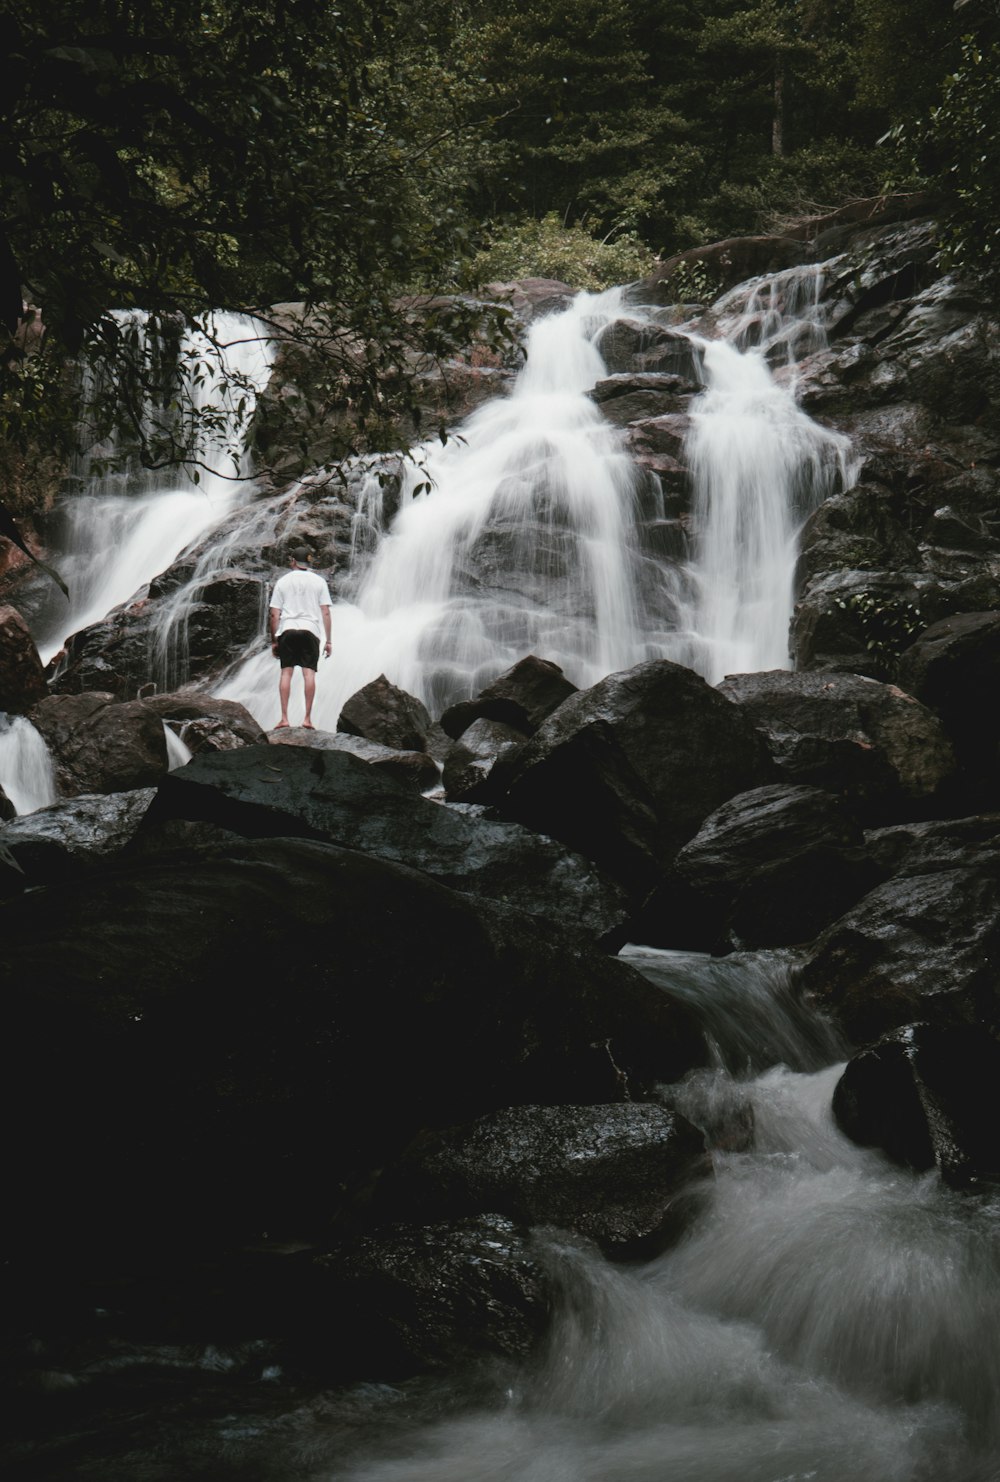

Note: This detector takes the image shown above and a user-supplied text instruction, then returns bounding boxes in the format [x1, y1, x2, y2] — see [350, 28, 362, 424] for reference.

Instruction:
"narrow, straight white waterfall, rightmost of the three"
[669, 267, 853, 683]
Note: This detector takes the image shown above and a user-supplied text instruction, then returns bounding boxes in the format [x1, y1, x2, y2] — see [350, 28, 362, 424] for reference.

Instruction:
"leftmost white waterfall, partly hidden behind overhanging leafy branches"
[25, 313, 273, 662]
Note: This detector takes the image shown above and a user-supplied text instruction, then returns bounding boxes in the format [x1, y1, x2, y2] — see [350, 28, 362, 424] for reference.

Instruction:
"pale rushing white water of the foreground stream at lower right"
[311, 948, 1000, 1482]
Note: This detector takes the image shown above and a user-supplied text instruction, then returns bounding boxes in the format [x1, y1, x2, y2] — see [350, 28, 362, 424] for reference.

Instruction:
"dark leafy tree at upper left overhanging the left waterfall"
[0, 0, 503, 512]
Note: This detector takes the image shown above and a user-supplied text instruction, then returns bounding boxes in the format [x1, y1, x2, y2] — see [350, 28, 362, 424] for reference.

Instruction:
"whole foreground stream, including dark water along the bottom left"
[9, 948, 1000, 1482]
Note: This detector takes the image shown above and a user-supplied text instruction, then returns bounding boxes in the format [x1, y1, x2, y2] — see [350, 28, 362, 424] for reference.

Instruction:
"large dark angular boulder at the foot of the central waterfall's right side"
[498, 659, 770, 897]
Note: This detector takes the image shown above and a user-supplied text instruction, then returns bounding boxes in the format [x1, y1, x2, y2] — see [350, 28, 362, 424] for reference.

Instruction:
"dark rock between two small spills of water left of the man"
[31, 694, 167, 797]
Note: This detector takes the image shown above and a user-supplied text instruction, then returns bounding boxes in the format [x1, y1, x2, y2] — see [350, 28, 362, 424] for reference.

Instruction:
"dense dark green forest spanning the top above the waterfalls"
[0, 0, 1000, 515]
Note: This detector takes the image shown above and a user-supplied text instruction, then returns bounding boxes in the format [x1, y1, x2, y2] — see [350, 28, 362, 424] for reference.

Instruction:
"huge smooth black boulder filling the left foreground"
[0, 841, 705, 1269]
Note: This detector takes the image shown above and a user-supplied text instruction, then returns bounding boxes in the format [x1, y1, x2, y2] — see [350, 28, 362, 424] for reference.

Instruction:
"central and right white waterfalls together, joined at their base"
[219, 270, 850, 729]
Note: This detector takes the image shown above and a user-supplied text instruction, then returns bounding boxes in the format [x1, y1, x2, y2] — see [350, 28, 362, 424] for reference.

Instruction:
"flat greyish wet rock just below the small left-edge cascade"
[0, 787, 156, 885]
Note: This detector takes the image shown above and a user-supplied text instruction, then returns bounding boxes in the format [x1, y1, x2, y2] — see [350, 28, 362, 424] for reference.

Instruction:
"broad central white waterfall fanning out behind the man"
[221, 290, 664, 729]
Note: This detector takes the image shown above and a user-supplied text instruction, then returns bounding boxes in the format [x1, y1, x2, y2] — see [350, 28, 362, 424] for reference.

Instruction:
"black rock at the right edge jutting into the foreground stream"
[833, 1024, 1000, 1187]
